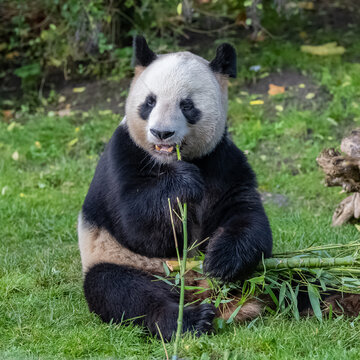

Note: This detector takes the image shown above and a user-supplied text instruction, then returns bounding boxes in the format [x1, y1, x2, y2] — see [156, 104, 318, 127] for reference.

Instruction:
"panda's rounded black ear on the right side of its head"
[209, 43, 236, 78]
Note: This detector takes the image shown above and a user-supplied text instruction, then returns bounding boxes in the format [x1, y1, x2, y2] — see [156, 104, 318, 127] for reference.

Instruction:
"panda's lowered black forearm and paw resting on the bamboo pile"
[204, 187, 272, 281]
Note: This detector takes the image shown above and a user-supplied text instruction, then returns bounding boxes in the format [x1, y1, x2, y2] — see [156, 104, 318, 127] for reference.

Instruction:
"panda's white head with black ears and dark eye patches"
[126, 36, 236, 163]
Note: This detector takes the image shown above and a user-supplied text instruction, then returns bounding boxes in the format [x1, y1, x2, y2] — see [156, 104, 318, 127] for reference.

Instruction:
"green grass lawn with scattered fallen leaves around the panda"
[0, 8, 360, 360]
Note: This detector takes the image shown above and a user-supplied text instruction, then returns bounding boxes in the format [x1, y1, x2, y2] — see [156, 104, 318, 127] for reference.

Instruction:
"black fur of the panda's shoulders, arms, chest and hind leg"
[82, 37, 272, 339]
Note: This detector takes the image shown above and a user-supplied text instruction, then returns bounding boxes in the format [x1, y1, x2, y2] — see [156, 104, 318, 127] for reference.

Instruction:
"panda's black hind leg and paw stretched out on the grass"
[84, 263, 215, 340]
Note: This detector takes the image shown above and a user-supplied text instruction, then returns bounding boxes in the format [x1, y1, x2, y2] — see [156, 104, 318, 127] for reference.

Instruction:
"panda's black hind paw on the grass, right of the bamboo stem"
[184, 304, 216, 336]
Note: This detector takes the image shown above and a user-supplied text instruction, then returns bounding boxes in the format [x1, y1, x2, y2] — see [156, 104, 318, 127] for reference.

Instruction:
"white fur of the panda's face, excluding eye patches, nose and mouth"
[126, 52, 227, 162]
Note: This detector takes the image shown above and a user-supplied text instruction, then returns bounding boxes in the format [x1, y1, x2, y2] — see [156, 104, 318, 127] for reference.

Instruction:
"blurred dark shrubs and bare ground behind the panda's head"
[0, 0, 360, 112]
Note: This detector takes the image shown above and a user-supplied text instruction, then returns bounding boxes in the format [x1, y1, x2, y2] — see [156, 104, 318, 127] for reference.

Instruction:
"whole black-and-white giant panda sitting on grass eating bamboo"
[78, 36, 272, 339]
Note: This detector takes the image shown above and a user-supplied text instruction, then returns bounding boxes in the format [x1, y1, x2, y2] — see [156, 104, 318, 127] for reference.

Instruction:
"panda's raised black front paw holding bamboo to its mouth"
[172, 161, 205, 202]
